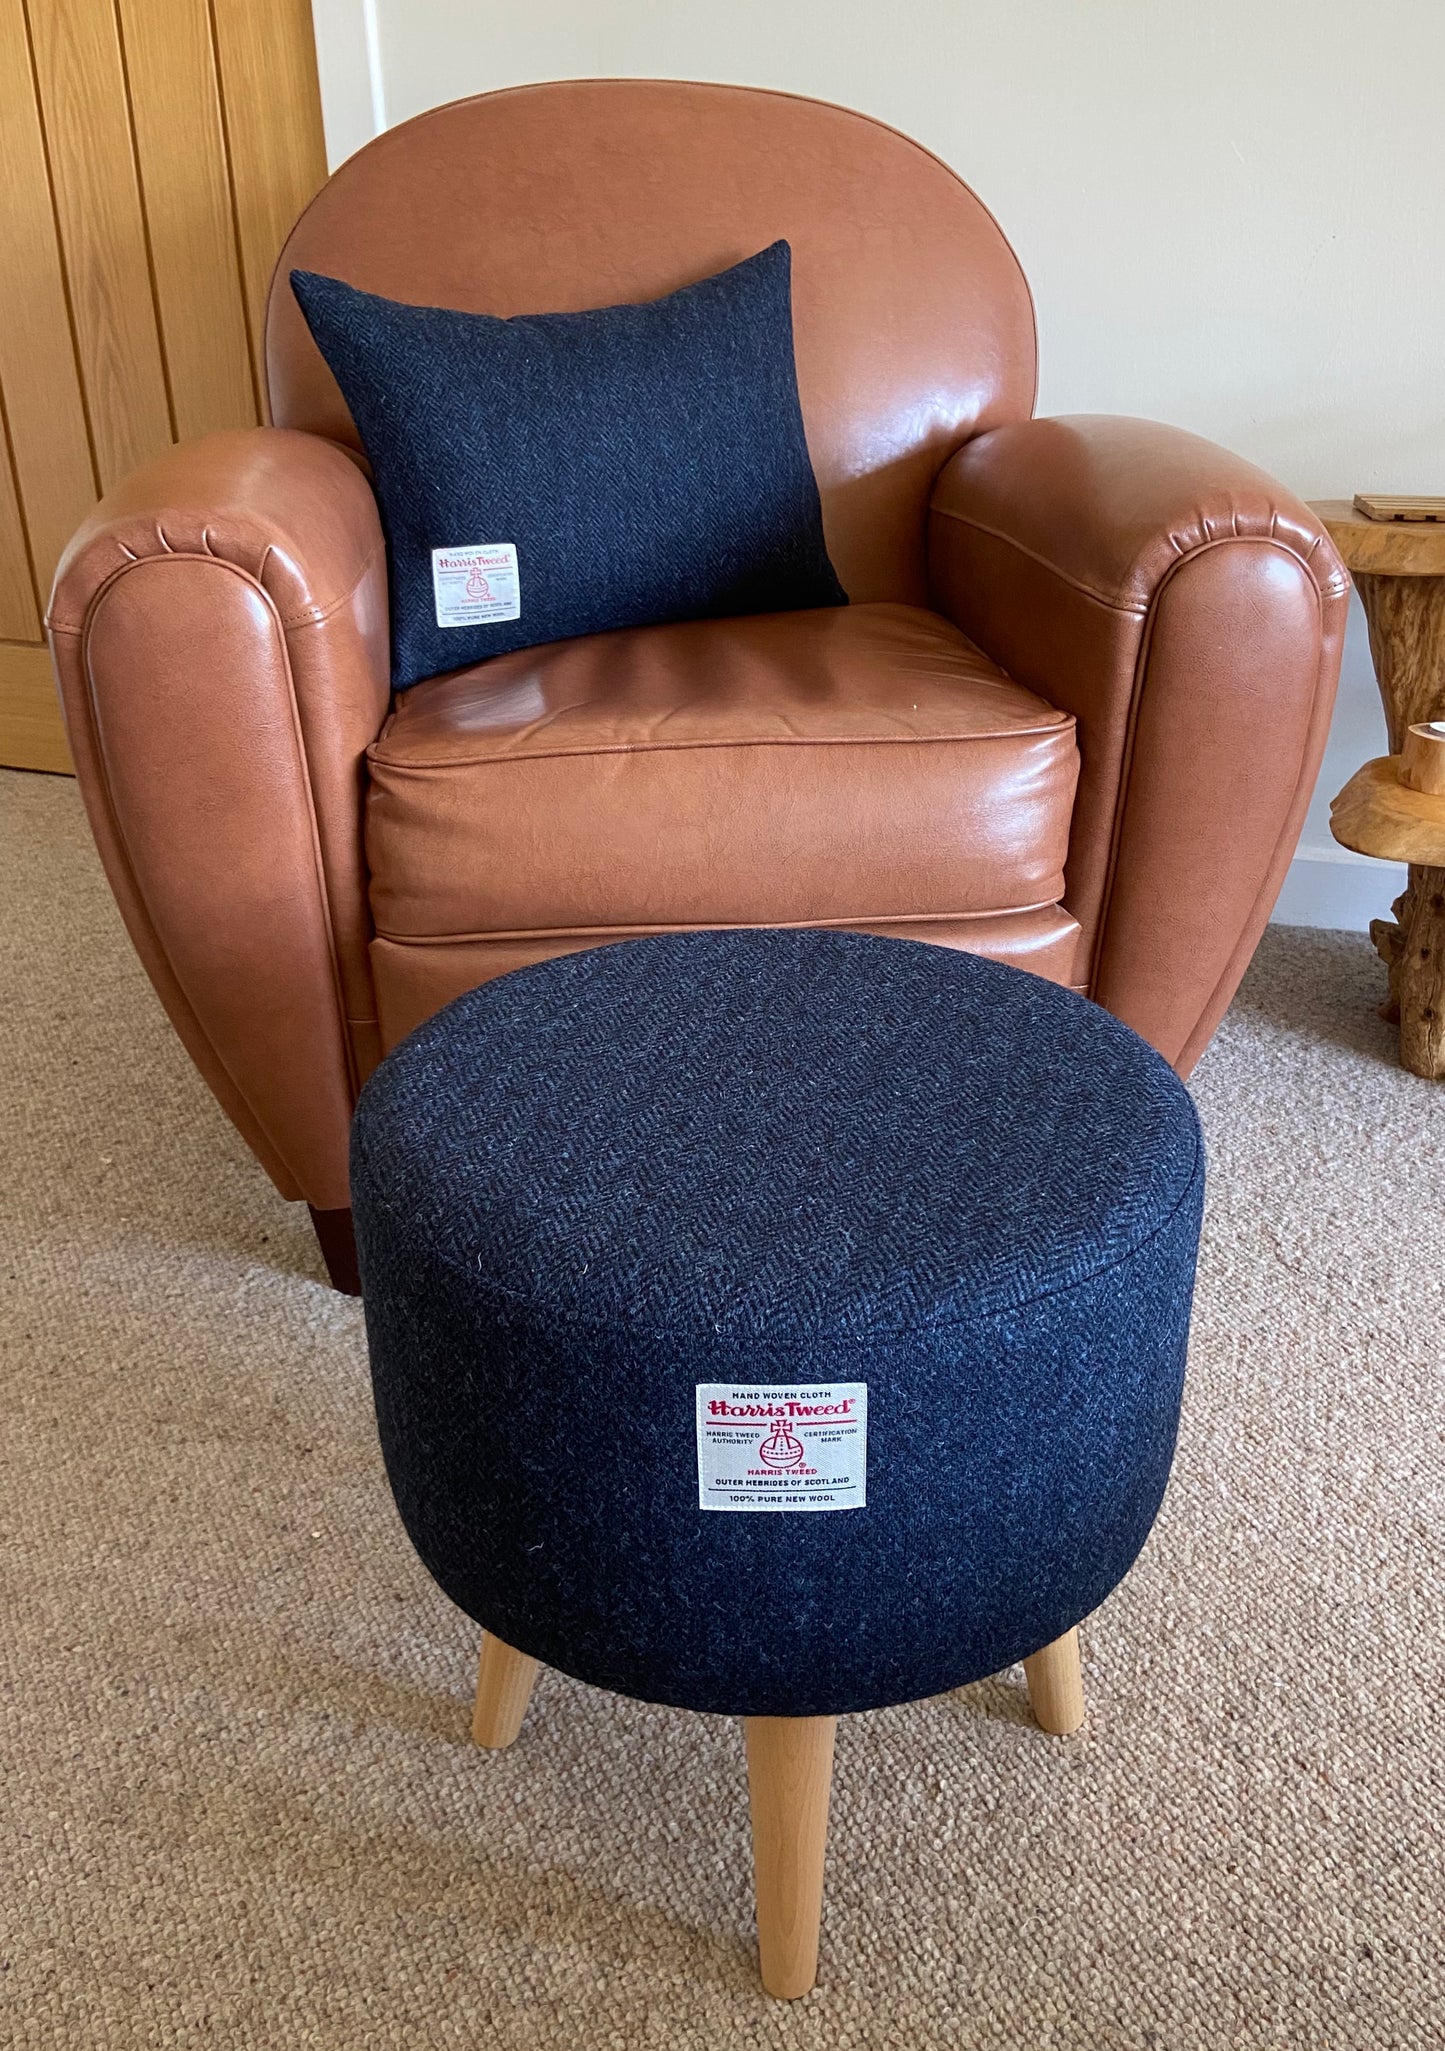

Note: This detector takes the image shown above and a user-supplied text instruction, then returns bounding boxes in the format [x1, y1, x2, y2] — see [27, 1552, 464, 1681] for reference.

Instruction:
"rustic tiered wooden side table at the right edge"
[1314, 498, 1445, 1077]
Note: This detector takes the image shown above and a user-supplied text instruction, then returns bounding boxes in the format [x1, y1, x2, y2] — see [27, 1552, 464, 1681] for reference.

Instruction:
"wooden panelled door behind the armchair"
[0, 0, 326, 769]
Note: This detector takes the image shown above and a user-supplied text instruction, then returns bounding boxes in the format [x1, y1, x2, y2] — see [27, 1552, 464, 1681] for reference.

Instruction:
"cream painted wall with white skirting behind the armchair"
[314, 0, 1445, 925]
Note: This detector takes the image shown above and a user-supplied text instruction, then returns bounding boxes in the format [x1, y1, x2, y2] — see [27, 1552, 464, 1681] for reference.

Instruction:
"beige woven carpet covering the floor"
[0, 775, 1445, 2051]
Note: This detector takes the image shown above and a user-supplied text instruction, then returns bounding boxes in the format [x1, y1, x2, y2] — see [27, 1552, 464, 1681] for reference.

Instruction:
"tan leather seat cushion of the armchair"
[367, 605, 1078, 939]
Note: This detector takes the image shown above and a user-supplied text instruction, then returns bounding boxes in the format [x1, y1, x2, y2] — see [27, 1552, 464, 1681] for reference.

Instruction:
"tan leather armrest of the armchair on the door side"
[47, 429, 389, 1210]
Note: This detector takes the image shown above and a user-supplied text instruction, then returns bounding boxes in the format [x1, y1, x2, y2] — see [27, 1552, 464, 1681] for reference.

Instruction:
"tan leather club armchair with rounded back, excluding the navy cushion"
[49, 80, 1349, 1282]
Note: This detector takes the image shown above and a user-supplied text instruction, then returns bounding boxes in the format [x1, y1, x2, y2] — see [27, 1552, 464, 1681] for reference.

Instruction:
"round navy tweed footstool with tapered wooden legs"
[353, 931, 1203, 1996]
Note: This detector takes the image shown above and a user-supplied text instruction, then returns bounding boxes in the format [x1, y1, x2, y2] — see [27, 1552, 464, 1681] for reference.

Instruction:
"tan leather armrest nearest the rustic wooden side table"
[928, 414, 1349, 1075]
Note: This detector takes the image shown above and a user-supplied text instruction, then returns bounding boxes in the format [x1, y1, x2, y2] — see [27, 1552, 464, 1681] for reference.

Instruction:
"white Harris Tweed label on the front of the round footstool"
[697, 1382, 867, 1510]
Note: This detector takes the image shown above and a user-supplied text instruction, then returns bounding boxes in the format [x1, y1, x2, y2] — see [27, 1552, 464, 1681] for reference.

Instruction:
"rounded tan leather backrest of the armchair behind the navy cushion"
[266, 78, 1035, 603]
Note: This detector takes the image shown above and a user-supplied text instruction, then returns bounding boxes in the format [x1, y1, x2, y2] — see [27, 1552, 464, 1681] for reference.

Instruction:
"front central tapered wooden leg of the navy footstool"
[742, 1717, 838, 2002]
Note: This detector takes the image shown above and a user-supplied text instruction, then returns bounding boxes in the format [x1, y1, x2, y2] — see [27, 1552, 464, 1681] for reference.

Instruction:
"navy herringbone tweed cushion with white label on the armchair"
[291, 242, 847, 689]
